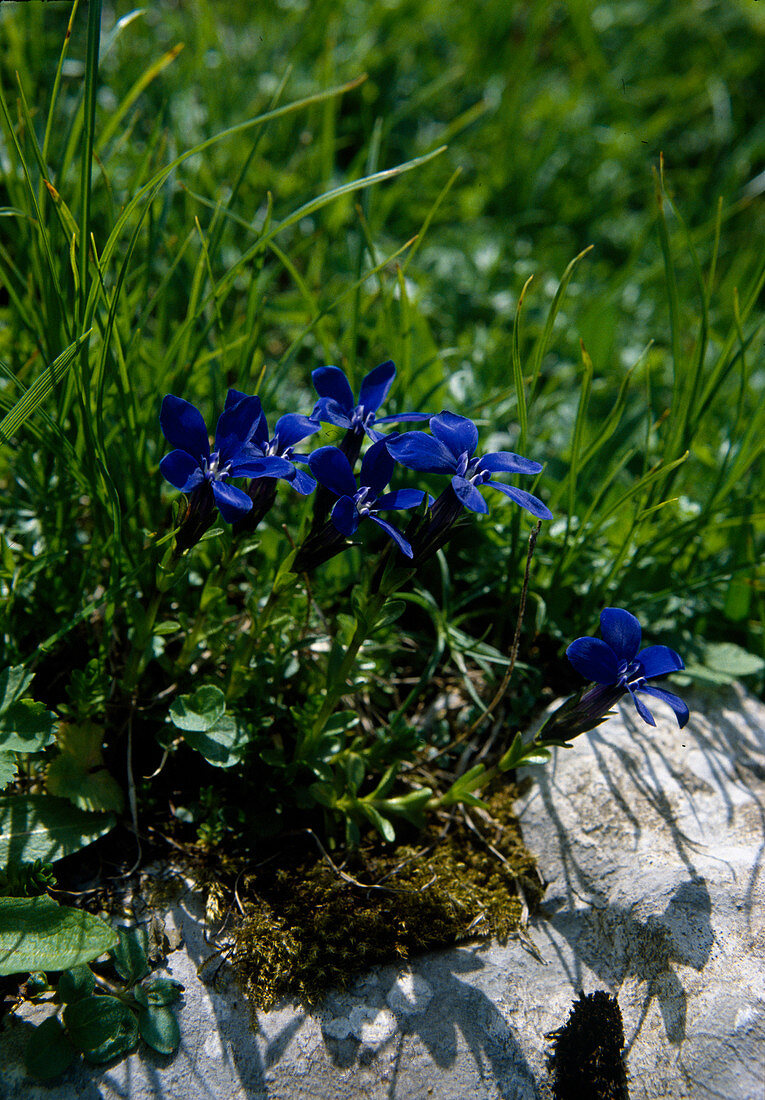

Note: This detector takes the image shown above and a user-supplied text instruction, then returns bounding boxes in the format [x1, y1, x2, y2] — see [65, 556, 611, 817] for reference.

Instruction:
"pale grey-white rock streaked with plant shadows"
[0, 689, 765, 1100]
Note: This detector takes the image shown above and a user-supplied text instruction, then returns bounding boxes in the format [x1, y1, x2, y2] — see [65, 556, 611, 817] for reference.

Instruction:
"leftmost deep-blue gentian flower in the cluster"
[160, 394, 294, 524]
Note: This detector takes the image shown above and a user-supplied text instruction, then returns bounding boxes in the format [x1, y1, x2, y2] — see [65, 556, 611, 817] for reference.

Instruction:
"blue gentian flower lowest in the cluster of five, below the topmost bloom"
[308, 440, 426, 558]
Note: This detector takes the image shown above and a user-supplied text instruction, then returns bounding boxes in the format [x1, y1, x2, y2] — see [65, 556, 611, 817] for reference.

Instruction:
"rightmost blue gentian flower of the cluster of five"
[387, 411, 553, 519]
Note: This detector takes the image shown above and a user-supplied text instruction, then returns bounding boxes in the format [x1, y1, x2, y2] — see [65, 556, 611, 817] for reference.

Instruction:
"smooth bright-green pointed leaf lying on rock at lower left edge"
[0, 894, 117, 976]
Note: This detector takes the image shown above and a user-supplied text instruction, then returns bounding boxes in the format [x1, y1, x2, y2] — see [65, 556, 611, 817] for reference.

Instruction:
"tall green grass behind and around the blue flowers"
[0, 0, 765, 686]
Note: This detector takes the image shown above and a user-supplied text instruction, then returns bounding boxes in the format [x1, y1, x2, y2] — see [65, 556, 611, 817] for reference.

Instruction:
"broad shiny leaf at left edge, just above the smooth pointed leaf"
[0, 794, 114, 866]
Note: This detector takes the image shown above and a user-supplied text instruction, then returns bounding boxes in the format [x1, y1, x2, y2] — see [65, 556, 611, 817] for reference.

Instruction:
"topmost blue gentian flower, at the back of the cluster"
[310, 360, 428, 442]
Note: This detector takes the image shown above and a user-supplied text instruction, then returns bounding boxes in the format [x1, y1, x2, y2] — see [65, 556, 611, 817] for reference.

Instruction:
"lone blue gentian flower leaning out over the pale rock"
[566, 607, 688, 728]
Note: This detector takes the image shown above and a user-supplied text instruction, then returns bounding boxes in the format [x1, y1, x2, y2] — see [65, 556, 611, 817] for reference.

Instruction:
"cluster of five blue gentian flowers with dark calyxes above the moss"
[160, 360, 551, 572]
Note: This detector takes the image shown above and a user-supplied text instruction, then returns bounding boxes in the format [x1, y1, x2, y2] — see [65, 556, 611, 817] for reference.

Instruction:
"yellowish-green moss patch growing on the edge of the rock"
[233, 788, 540, 1009]
